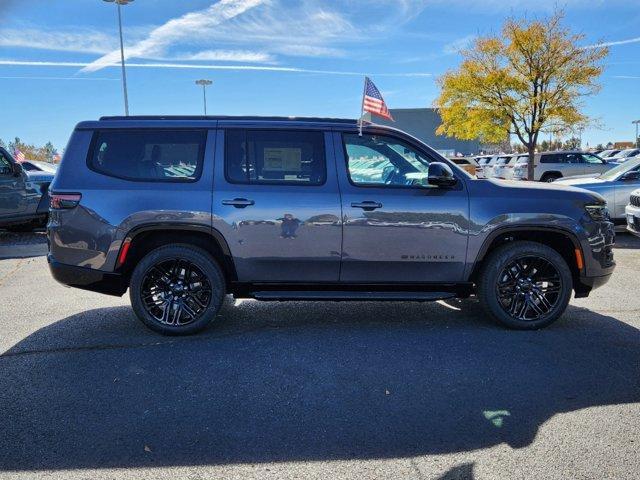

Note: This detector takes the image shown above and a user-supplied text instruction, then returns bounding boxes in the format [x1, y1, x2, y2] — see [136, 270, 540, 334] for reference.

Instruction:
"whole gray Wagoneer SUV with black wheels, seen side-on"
[48, 117, 615, 335]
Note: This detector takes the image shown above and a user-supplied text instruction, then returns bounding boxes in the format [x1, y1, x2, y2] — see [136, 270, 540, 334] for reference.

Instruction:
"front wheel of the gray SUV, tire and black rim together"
[477, 241, 573, 330]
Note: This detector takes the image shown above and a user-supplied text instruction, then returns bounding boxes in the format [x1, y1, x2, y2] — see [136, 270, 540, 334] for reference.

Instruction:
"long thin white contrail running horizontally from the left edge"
[0, 60, 433, 77]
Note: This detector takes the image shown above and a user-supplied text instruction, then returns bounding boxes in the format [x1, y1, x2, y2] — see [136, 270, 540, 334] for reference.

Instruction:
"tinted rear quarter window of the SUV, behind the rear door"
[88, 130, 207, 182]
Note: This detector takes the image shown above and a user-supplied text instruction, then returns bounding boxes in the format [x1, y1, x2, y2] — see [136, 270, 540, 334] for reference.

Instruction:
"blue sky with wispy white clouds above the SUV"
[0, 0, 640, 149]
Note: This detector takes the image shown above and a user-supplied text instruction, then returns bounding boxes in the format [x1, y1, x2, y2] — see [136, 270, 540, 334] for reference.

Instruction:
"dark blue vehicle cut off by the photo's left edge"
[0, 148, 53, 231]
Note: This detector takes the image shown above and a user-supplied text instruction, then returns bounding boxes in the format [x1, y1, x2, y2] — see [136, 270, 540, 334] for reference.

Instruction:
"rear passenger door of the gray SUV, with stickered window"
[212, 129, 342, 282]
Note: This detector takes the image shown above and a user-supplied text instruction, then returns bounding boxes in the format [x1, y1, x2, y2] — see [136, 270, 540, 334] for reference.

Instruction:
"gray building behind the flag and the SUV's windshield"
[364, 108, 498, 156]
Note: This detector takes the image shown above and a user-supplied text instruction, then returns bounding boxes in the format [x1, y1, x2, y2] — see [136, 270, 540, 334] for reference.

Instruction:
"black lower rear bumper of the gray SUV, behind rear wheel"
[47, 255, 128, 297]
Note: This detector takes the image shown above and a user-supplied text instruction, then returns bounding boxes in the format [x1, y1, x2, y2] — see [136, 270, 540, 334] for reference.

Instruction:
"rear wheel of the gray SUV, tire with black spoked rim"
[129, 244, 226, 335]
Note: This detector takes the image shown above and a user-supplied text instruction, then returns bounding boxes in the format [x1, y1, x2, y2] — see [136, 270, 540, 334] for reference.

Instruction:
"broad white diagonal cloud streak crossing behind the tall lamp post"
[83, 0, 267, 72]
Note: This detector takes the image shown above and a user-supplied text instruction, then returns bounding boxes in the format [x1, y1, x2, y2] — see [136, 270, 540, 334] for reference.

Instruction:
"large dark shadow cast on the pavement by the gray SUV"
[0, 300, 640, 471]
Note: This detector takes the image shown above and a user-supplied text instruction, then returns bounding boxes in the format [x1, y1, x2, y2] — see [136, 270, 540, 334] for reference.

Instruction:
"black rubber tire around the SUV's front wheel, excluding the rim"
[478, 241, 573, 330]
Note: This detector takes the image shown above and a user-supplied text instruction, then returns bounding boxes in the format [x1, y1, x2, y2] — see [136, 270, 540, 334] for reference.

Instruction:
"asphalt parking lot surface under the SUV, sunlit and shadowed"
[0, 232, 640, 480]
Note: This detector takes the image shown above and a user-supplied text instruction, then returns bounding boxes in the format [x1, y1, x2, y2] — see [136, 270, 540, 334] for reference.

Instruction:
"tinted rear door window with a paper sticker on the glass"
[225, 128, 327, 185]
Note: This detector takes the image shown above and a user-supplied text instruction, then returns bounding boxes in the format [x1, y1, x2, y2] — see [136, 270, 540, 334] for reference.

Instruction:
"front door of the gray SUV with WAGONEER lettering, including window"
[334, 133, 469, 283]
